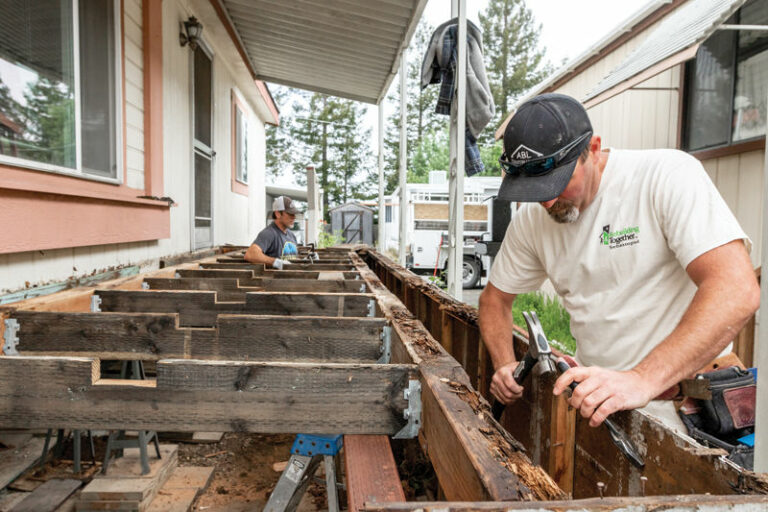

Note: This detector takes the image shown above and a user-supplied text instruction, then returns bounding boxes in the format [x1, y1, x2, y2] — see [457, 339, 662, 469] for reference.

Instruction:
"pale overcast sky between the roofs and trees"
[272, 0, 657, 185]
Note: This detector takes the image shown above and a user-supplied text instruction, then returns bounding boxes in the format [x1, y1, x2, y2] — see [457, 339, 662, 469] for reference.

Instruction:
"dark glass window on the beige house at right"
[684, 0, 768, 150]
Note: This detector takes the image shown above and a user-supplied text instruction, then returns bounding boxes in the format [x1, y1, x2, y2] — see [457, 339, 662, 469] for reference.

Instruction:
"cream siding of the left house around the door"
[0, 0, 269, 294]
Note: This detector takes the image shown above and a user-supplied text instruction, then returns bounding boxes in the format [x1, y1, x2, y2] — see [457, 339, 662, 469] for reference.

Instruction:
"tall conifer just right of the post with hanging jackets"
[479, 0, 552, 134]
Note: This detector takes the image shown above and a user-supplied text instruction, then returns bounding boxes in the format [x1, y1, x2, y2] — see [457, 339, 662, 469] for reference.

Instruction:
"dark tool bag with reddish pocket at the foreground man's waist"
[678, 366, 756, 451]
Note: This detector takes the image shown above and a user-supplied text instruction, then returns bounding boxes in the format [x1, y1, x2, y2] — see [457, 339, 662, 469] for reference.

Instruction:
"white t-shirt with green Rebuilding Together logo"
[489, 149, 750, 428]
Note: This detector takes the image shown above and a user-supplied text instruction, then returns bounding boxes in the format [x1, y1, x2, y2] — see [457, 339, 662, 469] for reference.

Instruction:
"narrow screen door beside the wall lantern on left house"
[192, 45, 216, 249]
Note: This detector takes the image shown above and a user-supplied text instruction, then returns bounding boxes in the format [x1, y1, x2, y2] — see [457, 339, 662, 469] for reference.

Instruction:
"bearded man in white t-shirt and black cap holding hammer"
[480, 94, 760, 430]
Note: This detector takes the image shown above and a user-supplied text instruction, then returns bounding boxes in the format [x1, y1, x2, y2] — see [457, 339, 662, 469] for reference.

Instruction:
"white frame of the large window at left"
[0, 0, 125, 185]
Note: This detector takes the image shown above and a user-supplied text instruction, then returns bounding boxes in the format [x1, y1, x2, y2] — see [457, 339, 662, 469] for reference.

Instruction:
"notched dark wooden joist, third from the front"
[94, 290, 376, 327]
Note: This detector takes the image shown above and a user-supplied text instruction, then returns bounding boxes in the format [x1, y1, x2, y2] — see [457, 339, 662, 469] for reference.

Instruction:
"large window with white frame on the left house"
[0, 0, 121, 181]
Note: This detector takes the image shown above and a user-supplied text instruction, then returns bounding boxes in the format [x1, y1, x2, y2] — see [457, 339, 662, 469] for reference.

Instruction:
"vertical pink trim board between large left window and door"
[143, 0, 165, 196]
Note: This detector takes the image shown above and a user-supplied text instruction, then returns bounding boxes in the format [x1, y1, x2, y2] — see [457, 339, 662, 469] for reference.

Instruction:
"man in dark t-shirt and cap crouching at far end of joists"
[244, 196, 299, 270]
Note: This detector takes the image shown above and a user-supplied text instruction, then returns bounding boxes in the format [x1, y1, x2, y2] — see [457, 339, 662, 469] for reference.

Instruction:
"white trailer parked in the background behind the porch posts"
[384, 171, 510, 288]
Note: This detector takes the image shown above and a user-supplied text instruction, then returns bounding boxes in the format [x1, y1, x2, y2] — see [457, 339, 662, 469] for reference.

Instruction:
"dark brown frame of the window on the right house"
[681, 4, 768, 153]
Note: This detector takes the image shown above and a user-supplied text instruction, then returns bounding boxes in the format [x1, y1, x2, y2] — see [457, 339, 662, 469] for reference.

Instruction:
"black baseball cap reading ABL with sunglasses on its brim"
[499, 93, 592, 202]
